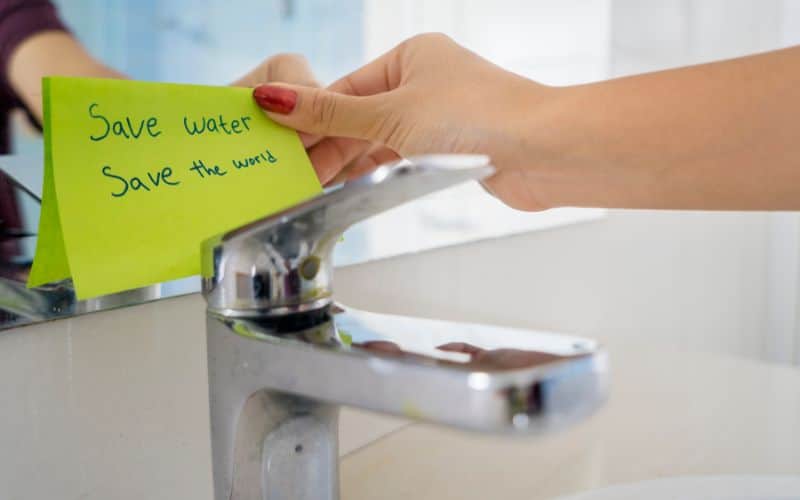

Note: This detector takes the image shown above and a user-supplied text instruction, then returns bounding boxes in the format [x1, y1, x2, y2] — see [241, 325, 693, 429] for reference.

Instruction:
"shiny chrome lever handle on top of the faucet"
[201, 155, 494, 318]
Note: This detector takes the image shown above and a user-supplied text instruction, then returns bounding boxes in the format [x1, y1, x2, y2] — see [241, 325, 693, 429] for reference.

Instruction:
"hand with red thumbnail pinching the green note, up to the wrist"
[253, 34, 555, 210]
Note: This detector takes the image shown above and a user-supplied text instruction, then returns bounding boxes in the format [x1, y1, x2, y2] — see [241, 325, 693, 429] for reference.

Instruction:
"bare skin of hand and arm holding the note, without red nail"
[255, 34, 800, 210]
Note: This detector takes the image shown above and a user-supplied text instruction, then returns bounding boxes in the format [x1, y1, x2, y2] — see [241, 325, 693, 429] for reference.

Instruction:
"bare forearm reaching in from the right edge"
[528, 48, 800, 210]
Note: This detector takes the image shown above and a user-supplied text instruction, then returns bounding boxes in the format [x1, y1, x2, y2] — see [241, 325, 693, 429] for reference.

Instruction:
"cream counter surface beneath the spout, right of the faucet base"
[341, 343, 800, 500]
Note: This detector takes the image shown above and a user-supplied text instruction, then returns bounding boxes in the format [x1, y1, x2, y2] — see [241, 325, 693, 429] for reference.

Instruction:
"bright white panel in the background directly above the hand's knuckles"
[364, 0, 611, 84]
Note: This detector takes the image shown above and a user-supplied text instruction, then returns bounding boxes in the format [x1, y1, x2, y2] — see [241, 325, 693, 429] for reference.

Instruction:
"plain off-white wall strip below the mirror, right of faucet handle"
[336, 211, 768, 357]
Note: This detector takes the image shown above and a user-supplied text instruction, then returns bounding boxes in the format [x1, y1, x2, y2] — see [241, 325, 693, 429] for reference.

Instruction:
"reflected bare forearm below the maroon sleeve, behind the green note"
[8, 31, 123, 119]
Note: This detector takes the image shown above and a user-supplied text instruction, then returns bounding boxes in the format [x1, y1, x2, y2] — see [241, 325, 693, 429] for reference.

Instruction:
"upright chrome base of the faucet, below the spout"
[208, 317, 339, 500]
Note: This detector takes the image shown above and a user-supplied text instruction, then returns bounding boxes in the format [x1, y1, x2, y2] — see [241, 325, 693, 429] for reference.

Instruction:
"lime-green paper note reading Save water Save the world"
[29, 77, 321, 298]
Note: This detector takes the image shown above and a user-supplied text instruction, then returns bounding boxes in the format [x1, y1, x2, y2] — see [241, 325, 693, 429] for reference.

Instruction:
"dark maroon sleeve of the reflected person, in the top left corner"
[0, 0, 65, 154]
